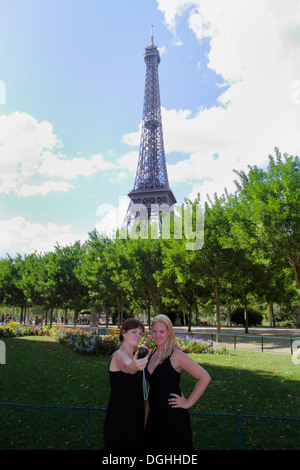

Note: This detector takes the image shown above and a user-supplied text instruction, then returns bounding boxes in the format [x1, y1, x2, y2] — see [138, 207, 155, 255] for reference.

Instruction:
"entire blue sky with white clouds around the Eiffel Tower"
[0, 0, 300, 256]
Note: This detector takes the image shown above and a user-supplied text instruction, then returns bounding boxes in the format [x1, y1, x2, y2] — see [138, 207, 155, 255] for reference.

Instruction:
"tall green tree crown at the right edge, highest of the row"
[232, 149, 300, 302]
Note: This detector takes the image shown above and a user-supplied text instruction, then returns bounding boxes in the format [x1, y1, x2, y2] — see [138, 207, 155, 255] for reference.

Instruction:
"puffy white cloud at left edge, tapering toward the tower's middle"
[0, 111, 119, 197]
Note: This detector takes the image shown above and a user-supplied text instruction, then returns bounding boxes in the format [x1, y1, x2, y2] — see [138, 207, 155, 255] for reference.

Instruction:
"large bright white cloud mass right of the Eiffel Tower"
[151, 0, 300, 200]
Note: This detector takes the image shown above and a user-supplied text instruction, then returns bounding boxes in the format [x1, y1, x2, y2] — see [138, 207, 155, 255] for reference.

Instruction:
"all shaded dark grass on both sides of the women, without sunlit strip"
[0, 337, 300, 450]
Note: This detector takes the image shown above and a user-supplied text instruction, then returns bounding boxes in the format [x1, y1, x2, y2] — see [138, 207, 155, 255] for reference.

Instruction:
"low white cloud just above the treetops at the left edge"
[0, 216, 88, 256]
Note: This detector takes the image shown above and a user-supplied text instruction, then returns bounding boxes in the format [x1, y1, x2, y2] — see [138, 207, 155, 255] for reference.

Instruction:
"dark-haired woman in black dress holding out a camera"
[103, 318, 148, 451]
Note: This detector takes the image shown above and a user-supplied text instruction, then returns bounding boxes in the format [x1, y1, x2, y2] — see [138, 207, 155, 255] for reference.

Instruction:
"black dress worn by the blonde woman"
[146, 348, 193, 453]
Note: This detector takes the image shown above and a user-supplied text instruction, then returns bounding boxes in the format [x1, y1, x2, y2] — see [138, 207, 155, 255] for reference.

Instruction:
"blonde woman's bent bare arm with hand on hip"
[169, 350, 211, 409]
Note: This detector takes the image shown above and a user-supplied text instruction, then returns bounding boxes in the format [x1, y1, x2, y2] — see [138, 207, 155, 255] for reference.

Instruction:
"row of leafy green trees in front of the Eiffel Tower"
[0, 149, 300, 332]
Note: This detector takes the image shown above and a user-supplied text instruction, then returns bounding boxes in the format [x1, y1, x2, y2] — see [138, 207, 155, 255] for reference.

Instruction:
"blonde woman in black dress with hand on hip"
[146, 315, 211, 453]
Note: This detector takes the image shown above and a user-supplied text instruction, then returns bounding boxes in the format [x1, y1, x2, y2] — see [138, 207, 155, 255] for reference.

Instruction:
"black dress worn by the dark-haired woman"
[103, 362, 145, 451]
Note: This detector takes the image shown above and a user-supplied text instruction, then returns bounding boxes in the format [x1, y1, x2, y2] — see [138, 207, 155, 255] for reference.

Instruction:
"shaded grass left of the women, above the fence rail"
[0, 337, 109, 406]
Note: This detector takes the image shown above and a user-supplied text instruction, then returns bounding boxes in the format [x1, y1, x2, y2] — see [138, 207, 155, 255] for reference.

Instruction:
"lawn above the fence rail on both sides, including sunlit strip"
[0, 336, 300, 448]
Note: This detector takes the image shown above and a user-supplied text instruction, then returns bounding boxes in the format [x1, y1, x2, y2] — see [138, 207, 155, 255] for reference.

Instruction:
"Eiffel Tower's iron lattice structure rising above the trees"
[125, 27, 176, 225]
